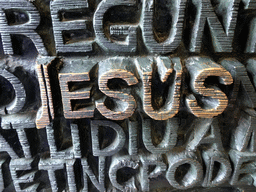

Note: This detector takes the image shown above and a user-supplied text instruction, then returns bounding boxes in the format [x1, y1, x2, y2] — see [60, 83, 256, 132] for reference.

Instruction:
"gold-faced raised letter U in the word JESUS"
[136, 57, 182, 120]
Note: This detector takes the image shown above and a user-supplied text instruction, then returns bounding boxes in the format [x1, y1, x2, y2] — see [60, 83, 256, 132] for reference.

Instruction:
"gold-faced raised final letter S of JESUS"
[186, 57, 233, 118]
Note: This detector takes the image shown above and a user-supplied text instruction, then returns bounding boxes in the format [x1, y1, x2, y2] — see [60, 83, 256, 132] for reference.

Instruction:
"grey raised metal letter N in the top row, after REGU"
[189, 0, 240, 52]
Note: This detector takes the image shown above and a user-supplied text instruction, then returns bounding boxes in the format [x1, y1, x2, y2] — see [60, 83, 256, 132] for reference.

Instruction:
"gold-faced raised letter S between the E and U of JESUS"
[96, 57, 138, 120]
